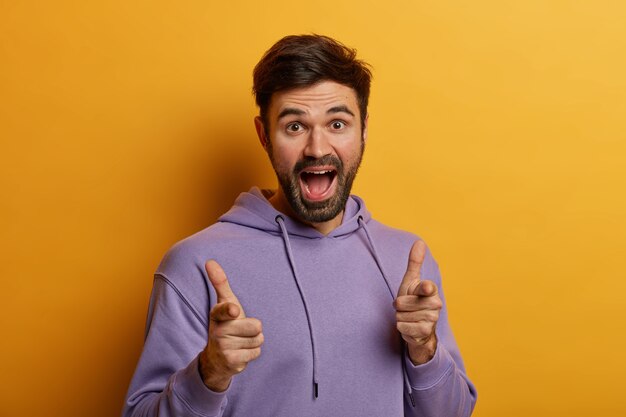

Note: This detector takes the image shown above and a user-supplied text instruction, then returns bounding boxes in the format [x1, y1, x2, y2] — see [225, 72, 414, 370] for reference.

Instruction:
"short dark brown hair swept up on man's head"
[252, 34, 372, 131]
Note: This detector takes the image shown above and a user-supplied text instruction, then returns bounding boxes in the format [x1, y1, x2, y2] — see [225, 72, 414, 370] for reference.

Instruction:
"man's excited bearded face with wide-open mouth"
[257, 81, 367, 223]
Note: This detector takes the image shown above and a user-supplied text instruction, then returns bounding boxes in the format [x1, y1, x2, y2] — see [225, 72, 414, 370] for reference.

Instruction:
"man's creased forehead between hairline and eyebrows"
[268, 81, 359, 120]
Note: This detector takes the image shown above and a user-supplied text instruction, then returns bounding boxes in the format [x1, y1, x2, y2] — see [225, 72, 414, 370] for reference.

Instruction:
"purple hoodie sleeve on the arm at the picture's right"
[404, 255, 476, 417]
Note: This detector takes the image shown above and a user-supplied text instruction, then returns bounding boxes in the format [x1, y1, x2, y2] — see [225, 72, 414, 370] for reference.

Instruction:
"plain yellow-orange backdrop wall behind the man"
[0, 0, 626, 417]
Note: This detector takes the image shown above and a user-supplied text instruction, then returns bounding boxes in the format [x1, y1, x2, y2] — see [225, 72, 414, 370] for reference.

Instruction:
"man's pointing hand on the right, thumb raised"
[393, 240, 443, 365]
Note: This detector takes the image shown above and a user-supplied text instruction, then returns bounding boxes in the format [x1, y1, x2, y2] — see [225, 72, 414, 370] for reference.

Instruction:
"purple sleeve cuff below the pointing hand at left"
[173, 356, 230, 416]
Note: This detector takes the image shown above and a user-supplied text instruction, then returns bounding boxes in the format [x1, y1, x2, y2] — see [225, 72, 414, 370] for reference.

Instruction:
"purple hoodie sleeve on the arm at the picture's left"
[122, 275, 228, 417]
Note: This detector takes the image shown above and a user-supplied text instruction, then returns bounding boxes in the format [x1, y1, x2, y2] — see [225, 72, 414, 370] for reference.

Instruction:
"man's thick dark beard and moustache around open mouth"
[268, 148, 363, 223]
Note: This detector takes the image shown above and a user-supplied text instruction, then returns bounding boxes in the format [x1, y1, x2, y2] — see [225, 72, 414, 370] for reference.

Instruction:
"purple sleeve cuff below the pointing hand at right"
[404, 343, 454, 391]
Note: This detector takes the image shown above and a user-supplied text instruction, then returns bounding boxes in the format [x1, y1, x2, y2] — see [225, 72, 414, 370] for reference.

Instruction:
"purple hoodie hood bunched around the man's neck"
[218, 187, 371, 239]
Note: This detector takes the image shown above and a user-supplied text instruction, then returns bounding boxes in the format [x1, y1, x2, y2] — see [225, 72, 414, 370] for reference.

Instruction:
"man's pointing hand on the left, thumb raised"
[199, 260, 263, 392]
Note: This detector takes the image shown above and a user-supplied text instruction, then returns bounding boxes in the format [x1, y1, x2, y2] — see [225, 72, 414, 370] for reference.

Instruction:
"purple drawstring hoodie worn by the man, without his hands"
[123, 188, 476, 417]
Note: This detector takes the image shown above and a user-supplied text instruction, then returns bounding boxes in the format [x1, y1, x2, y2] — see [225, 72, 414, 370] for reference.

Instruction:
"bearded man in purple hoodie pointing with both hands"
[123, 35, 476, 417]
